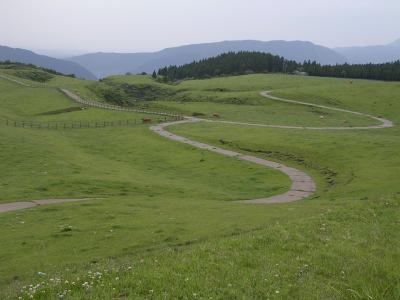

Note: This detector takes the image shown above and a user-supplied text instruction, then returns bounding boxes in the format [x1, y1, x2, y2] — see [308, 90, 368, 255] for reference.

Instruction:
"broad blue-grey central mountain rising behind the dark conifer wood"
[69, 40, 346, 77]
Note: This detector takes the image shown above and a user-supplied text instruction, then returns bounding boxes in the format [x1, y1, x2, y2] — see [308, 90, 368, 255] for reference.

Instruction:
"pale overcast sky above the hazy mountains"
[0, 0, 400, 55]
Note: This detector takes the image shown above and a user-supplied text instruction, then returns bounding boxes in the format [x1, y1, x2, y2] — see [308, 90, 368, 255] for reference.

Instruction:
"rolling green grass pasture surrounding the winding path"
[0, 68, 400, 299]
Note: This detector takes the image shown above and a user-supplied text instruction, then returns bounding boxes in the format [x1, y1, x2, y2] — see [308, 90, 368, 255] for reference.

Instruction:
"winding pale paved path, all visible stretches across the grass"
[0, 75, 394, 213]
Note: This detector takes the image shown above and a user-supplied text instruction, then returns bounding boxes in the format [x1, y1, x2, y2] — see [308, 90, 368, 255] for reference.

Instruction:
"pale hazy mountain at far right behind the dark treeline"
[334, 39, 400, 64]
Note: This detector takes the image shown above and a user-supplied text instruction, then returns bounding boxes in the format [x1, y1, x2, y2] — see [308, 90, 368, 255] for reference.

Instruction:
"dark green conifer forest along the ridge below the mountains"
[153, 52, 400, 81]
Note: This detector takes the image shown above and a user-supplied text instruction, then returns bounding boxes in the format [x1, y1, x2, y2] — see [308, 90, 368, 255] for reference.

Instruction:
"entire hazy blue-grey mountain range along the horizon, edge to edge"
[0, 39, 400, 80]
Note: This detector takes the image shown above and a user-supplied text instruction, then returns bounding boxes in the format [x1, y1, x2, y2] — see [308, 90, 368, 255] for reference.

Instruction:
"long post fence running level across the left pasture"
[2, 116, 182, 129]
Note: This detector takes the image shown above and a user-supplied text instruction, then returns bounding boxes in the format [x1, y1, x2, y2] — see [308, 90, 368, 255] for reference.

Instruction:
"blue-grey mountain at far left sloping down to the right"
[0, 46, 97, 80]
